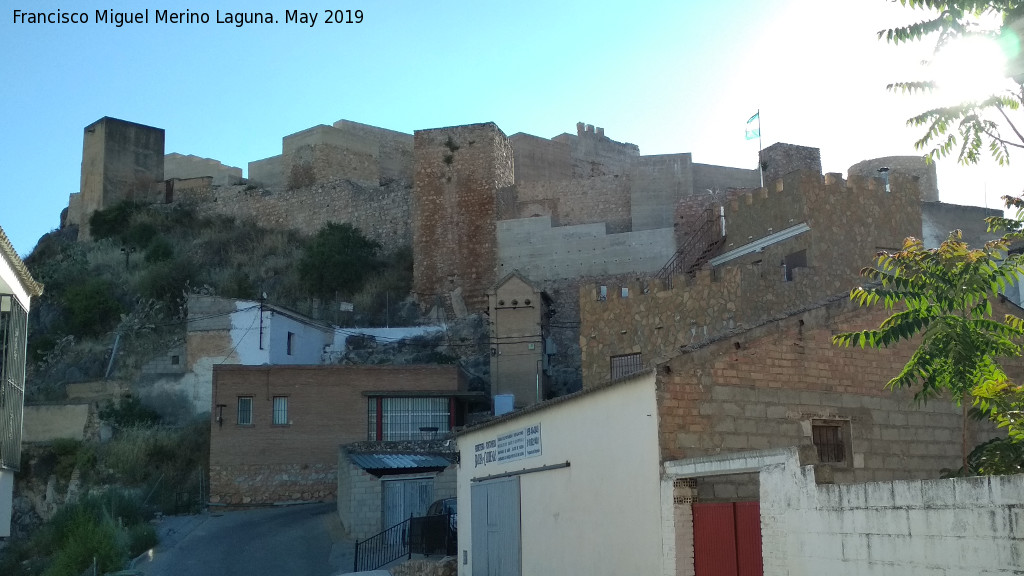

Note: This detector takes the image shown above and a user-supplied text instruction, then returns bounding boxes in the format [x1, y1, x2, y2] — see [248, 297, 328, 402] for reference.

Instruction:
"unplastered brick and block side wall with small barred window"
[657, 298, 1024, 483]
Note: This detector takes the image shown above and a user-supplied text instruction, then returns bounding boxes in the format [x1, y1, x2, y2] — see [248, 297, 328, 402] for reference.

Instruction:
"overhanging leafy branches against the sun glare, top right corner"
[879, 0, 1024, 164]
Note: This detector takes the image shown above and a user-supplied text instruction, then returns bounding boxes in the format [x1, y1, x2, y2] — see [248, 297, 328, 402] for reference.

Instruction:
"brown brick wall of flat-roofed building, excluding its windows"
[210, 365, 457, 504]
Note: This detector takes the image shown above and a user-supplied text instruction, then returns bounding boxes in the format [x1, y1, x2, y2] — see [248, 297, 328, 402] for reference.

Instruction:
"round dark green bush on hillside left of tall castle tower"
[299, 222, 381, 297]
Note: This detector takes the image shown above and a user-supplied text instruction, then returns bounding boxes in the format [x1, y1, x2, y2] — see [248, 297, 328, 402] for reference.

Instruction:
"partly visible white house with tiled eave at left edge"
[0, 229, 43, 538]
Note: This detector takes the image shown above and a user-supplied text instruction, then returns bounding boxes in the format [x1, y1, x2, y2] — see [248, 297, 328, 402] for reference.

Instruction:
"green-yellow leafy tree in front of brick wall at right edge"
[833, 231, 1024, 470]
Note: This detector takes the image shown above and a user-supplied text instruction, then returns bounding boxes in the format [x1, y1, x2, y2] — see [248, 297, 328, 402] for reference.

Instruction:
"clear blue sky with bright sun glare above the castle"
[0, 0, 1024, 255]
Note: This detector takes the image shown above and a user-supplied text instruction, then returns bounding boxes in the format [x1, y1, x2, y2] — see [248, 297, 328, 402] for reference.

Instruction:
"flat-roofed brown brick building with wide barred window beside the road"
[210, 365, 483, 516]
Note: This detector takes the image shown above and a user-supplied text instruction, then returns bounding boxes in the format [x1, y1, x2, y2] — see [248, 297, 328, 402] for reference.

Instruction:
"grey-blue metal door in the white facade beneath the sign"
[470, 477, 522, 576]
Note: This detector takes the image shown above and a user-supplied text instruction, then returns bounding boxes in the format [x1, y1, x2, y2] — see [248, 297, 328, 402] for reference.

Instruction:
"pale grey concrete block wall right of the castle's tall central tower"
[498, 216, 675, 282]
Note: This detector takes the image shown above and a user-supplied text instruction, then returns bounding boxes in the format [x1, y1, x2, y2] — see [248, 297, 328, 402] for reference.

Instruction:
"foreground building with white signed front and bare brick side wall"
[459, 296, 1024, 576]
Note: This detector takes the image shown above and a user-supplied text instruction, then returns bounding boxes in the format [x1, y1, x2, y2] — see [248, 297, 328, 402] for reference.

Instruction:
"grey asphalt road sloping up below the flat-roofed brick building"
[135, 503, 352, 576]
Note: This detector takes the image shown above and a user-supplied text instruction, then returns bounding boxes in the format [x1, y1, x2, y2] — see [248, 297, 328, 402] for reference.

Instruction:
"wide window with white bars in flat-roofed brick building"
[367, 398, 452, 441]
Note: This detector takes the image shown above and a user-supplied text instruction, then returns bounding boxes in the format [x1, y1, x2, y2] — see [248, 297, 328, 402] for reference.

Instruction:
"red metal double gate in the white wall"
[693, 502, 764, 576]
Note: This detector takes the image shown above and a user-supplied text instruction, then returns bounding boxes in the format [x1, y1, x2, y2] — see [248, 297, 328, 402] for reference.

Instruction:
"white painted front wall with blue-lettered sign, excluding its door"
[458, 373, 663, 576]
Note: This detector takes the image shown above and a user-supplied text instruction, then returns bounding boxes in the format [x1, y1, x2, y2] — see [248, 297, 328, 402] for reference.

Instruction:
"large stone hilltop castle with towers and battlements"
[66, 118, 987, 393]
